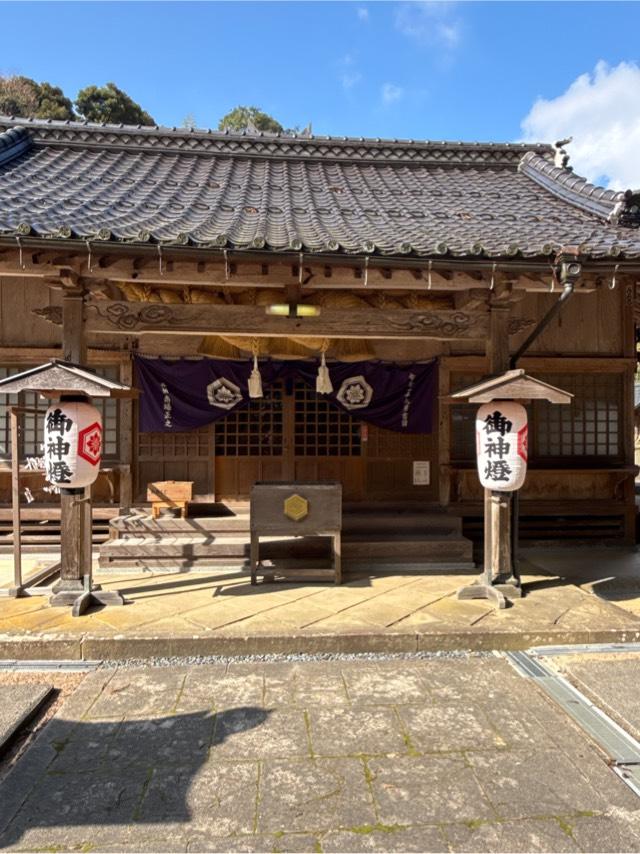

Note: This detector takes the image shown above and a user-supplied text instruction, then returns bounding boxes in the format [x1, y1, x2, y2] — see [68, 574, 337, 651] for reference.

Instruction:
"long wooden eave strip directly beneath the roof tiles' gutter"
[0, 237, 612, 293]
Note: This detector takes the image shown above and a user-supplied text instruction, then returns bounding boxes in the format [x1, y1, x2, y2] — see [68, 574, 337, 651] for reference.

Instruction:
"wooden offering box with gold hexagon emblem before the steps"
[250, 481, 342, 584]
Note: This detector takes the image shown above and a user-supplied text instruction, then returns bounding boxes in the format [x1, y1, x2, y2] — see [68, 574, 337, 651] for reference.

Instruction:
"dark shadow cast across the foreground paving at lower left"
[0, 706, 271, 850]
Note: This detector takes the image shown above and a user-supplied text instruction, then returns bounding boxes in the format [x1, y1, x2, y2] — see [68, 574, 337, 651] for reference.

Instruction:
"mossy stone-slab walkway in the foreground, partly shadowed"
[0, 656, 640, 852]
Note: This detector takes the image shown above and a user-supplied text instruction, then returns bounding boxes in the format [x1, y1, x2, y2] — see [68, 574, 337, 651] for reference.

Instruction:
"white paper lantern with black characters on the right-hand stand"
[476, 400, 529, 492]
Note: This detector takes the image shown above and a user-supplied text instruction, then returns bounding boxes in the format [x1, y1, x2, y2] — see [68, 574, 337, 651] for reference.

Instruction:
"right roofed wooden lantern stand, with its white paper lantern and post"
[451, 369, 573, 608]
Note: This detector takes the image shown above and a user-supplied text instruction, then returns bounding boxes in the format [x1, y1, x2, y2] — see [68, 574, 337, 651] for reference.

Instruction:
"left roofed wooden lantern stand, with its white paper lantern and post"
[0, 360, 137, 616]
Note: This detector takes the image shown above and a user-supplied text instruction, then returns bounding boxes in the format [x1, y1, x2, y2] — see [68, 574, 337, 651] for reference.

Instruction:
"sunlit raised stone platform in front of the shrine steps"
[0, 548, 640, 659]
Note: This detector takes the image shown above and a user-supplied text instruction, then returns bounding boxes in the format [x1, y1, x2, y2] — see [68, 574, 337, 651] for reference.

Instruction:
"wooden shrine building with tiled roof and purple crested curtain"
[0, 113, 640, 570]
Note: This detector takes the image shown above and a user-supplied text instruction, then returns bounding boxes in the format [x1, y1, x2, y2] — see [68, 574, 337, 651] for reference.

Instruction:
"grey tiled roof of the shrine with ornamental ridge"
[0, 118, 640, 258]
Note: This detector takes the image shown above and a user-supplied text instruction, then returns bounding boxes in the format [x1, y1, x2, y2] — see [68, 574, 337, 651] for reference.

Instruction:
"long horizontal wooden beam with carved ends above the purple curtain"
[48, 300, 496, 341]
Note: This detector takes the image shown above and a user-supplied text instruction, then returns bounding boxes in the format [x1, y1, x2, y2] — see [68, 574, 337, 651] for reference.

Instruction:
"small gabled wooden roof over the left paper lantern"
[0, 359, 138, 398]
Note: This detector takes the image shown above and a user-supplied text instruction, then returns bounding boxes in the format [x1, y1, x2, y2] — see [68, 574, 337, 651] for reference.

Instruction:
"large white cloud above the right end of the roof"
[521, 62, 640, 190]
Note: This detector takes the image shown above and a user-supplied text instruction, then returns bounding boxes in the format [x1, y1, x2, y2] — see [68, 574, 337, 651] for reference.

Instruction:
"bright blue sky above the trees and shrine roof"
[0, 2, 640, 183]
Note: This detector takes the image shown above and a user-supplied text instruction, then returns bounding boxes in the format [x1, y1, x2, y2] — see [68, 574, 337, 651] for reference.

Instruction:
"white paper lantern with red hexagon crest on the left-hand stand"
[44, 400, 102, 492]
